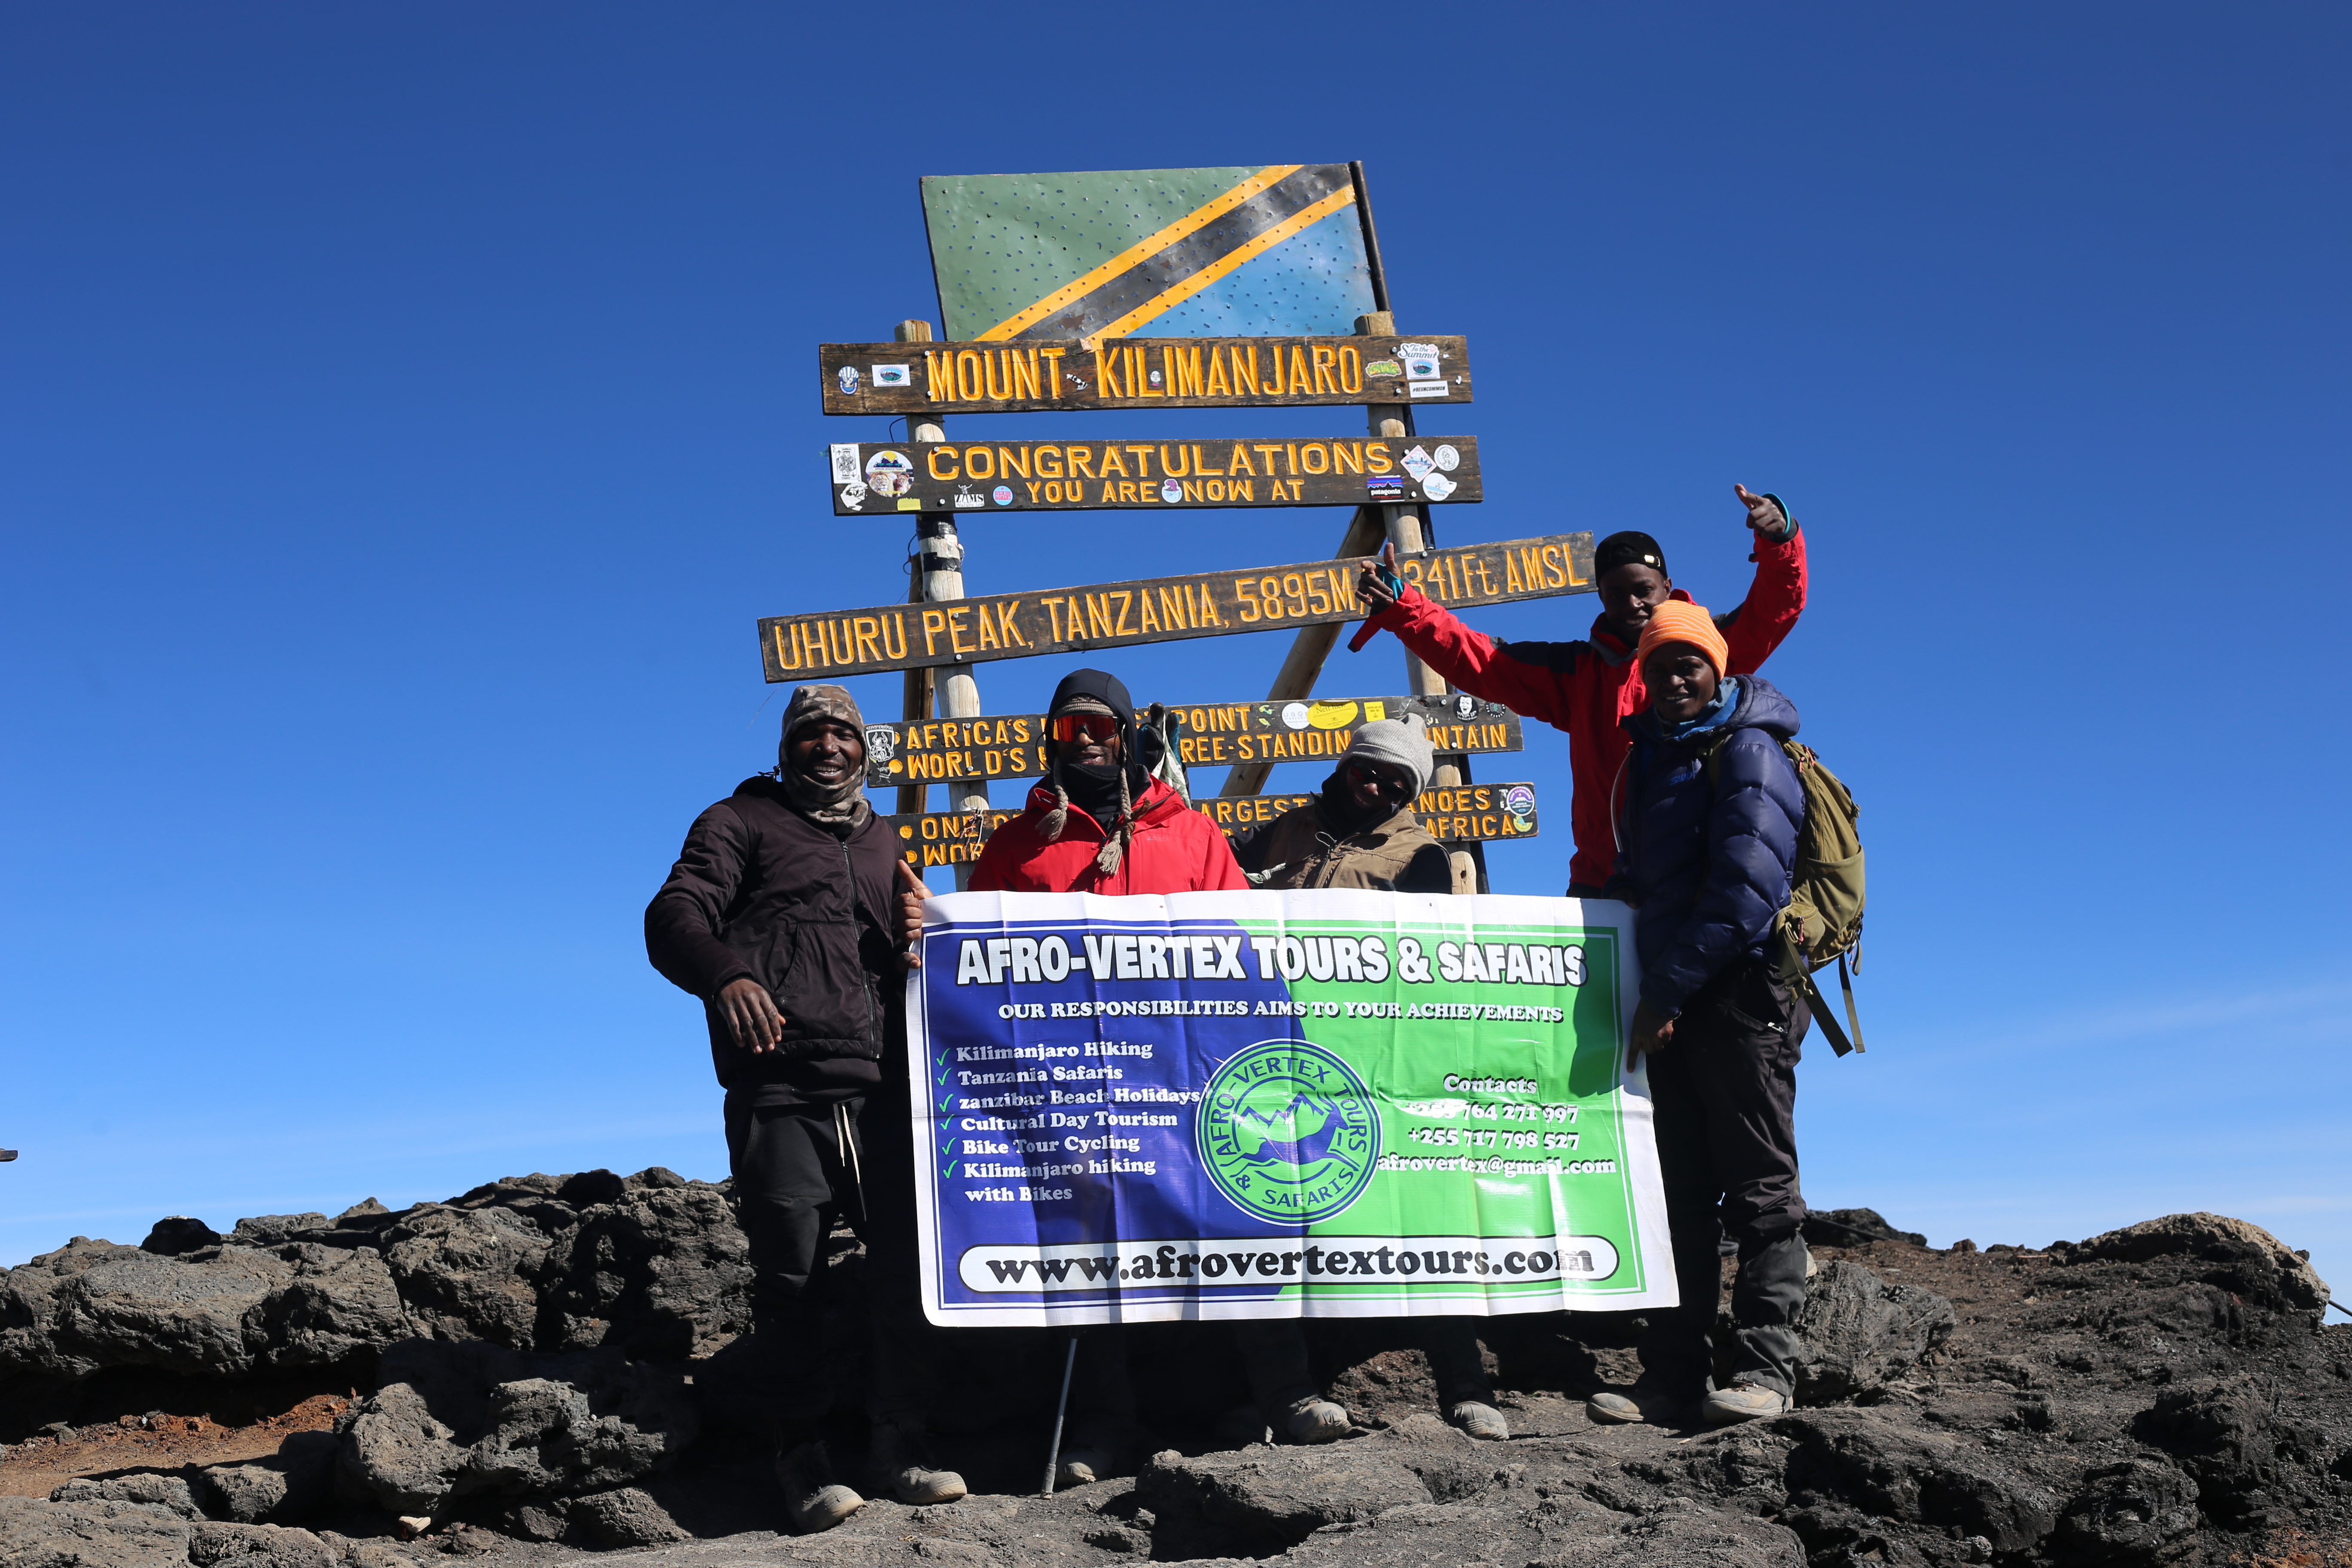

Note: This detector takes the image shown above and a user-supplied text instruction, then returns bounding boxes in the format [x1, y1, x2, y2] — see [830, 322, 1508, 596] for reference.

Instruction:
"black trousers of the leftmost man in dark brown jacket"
[727, 1096, 929, 1443]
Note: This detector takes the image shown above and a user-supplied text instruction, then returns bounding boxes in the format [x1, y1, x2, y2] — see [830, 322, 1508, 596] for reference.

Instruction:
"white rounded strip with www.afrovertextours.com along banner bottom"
[957, 1237, 1618, 1295]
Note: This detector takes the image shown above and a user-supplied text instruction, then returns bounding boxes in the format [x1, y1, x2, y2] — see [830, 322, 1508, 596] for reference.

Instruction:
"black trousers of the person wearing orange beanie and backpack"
[1642, 959, 1809, 1396]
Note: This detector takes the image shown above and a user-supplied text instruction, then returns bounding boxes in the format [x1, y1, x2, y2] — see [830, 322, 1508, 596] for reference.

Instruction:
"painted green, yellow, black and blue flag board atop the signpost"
[922, 162, 1376, 341]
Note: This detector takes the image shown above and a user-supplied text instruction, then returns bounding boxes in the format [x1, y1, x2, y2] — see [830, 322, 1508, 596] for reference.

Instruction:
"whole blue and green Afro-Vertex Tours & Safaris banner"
[908, 891, 1677, 1326]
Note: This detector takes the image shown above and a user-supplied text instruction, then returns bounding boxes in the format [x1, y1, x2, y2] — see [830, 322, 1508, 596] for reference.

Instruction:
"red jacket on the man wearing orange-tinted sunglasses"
[971, 778, 1249, 893]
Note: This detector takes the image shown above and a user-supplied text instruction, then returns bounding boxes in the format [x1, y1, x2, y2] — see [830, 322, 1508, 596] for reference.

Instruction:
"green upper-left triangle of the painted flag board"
[922, 165, 1265, 341]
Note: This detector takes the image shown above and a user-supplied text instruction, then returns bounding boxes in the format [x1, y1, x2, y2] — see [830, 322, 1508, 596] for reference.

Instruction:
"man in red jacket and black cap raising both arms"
[1357, 484, 1804, 898]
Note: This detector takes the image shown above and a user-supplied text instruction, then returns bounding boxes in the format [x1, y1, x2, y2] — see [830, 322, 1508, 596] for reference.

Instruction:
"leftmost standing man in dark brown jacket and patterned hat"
[644, 686, 965, 1530]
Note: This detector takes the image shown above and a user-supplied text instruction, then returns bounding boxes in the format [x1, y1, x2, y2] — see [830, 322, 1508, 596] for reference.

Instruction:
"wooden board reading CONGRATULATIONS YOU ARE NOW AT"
[828, 435, 1486, 517]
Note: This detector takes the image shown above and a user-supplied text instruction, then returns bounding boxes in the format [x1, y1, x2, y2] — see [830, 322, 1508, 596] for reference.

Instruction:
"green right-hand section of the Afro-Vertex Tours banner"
[1232, 919, 1651, 1300]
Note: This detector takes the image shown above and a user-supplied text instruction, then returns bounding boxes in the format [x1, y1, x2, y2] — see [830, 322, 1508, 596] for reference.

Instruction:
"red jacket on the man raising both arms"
[1371, 527, 1804, 891]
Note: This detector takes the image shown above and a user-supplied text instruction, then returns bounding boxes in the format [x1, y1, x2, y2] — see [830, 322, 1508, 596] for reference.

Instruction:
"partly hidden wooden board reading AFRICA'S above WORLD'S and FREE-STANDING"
[866, 693, 1524, 790]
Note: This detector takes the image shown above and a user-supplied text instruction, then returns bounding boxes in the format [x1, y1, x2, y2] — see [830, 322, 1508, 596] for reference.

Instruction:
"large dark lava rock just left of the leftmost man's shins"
[336, 1340, 696, 1514]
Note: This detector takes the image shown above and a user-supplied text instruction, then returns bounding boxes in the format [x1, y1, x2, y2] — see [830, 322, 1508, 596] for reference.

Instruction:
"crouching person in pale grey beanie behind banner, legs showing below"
[1232, 717, 1510, 1441]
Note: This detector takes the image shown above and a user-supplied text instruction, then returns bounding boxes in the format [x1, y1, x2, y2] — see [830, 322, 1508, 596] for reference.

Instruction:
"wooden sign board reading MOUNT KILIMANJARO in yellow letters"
[816, 336, 1470, 414]
